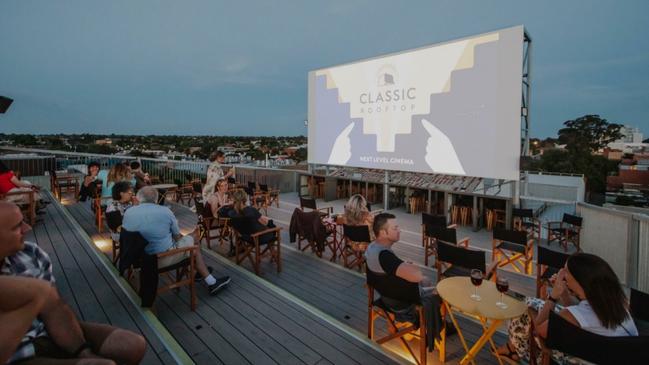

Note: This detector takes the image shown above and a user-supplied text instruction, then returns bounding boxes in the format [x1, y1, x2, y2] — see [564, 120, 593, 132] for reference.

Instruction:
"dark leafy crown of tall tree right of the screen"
[559, 114, 622, 153]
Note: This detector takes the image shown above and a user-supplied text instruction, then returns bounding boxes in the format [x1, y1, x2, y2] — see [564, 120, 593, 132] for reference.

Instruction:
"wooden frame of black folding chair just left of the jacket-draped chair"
[232, 227, 282, 275]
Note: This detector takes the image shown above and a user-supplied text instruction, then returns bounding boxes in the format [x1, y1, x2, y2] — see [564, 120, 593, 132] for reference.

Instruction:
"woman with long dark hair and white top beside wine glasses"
[498, 252, 638, 363]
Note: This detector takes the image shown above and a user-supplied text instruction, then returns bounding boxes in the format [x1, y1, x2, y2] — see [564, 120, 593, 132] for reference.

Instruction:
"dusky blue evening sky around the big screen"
[0, 0, 649, 138]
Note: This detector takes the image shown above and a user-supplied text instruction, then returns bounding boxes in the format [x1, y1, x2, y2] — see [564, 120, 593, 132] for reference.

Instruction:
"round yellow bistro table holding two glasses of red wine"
[437, 276, 527, 365]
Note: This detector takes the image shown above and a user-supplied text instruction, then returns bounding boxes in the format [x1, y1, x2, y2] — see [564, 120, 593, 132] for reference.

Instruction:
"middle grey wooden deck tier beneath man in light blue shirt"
[68, 199, 400, 364]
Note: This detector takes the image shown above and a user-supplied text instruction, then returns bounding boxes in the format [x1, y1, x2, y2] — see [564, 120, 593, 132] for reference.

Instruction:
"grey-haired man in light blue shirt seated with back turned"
[122, 186, 230, 295]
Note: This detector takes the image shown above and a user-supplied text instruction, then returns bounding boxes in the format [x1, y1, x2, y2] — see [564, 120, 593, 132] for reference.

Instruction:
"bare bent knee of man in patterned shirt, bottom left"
[81, 322, 146, 364]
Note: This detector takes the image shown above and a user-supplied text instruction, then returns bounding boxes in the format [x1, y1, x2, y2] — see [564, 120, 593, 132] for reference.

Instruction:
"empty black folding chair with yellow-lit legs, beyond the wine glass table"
[491, 227, 534, 275]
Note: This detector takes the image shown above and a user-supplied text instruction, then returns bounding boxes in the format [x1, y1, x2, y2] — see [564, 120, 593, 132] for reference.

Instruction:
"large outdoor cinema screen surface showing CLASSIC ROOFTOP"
[308, 26, 523, 180]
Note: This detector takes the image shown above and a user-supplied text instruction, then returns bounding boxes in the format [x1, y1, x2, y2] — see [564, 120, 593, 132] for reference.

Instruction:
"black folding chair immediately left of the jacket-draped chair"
[231, 216, 282, 275]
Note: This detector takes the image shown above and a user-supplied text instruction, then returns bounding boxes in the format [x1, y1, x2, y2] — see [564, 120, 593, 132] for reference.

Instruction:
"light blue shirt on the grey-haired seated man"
[122, 203, 180, 255]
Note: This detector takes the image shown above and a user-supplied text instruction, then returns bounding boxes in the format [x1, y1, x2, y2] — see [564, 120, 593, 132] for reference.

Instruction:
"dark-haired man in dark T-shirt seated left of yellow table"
[365, 213, 442, 351]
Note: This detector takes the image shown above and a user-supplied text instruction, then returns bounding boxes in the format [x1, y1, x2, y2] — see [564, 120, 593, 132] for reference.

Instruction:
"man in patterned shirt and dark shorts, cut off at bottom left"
[0, 202, 146, 364]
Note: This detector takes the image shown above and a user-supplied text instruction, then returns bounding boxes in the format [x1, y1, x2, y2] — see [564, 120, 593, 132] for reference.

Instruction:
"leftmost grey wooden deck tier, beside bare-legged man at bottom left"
[27, 192, 177, 364]
